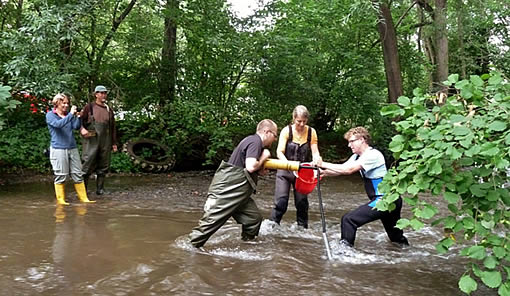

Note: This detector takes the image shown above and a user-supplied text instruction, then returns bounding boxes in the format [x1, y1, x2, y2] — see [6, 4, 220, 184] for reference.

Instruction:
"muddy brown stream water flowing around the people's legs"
[0, 171, 497, 296]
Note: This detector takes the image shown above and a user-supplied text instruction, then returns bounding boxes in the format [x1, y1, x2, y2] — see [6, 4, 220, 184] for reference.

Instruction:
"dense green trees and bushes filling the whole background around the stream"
[0, 0, 510, 295]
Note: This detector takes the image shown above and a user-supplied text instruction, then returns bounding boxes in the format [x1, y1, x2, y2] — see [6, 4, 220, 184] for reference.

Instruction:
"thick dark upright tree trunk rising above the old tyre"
[159, 0, 179, 106]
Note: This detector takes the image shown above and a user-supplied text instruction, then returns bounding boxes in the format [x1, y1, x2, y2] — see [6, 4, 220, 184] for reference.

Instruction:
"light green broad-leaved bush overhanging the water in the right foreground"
[377, 72, 510, 295]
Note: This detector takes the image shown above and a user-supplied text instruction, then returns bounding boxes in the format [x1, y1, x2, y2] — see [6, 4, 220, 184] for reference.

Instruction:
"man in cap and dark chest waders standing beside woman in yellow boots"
[80, 85, 117, 195]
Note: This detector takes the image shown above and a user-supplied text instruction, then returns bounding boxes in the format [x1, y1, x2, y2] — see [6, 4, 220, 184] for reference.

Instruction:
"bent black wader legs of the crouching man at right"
[341, 199, 407, 245]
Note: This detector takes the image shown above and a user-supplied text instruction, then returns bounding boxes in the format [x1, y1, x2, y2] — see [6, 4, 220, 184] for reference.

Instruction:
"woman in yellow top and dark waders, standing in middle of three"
[270, 105, 322, 228]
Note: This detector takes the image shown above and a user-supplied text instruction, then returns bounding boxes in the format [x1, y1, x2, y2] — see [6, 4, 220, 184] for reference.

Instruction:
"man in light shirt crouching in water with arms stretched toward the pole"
[321, 127, 409, 247]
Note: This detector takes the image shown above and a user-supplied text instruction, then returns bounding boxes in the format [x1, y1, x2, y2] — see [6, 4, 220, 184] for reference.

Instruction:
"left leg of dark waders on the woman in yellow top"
[270, 170, 294, 224]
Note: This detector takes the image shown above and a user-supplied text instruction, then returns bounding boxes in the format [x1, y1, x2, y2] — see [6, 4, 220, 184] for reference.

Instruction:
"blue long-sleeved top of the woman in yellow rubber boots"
[46, 109, 81, 149]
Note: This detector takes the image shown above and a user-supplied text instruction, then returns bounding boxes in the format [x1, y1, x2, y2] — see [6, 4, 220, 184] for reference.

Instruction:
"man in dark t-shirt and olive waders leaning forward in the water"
[190, 119, 278, 248]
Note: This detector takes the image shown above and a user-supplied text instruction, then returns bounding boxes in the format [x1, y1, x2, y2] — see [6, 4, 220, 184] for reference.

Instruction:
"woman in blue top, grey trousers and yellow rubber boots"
[46, 94, 95, 205]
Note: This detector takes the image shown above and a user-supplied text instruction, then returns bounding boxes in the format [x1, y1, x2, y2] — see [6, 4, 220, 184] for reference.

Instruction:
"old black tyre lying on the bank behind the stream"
[122, 138, 175, 173]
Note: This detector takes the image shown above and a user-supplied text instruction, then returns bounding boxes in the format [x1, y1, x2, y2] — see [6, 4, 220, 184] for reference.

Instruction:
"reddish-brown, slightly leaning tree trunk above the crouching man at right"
[377, 3, 403, 103]
